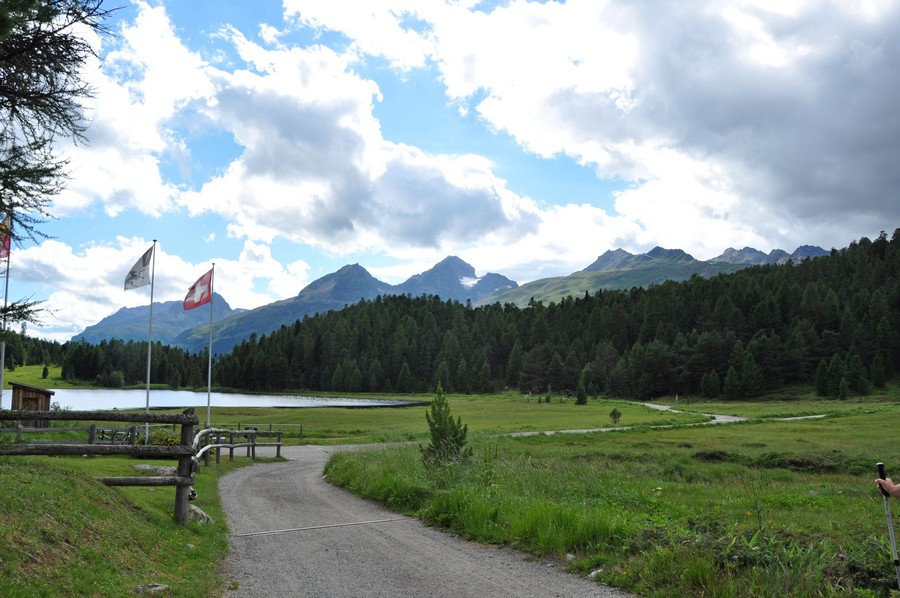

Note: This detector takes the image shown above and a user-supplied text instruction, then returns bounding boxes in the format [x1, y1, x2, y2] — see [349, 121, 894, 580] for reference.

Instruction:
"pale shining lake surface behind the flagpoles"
[42, 389, 417, 411]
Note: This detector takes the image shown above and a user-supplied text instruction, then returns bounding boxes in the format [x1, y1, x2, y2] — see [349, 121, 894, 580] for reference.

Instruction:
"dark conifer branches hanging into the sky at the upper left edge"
[0, 0, 110, 325]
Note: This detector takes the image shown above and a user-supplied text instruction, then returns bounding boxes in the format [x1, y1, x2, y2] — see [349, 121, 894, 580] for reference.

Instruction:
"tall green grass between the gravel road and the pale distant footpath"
[326, 403, 900, 596]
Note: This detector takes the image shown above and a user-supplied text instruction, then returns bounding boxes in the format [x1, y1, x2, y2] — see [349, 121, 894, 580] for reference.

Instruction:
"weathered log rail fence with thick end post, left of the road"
[0, 408, 200, 525]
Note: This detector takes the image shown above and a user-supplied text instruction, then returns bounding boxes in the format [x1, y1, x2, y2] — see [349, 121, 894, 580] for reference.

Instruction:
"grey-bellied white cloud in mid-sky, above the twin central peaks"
[180, 31, 533, 254]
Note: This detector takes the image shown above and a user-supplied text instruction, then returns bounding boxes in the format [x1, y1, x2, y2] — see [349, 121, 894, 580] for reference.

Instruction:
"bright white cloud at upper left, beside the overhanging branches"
[54, 2, 212, 217]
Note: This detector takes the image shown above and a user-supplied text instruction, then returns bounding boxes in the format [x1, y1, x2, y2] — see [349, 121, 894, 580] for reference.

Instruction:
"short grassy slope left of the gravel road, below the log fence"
[0, 457, 249, 598]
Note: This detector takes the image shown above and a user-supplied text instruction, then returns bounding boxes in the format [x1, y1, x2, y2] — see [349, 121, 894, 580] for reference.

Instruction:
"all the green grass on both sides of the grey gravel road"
[0, 368, 900, 597]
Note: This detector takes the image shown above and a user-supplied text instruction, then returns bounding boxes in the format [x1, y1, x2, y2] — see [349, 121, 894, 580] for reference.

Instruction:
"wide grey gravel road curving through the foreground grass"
[219, 446, 628, 598]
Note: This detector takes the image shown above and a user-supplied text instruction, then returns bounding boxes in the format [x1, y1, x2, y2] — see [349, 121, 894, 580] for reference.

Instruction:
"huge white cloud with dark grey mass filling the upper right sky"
[285, 0, 900, 254]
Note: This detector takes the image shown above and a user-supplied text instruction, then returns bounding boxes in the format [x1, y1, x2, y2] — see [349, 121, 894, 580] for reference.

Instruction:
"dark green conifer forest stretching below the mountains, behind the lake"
[62, 229, 900, 400]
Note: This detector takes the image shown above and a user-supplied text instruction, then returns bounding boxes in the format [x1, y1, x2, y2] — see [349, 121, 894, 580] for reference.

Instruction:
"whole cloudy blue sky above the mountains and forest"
[8, 0, 900, 342]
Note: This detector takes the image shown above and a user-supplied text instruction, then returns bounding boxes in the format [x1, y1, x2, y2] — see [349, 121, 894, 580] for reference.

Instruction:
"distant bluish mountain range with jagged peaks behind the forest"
[72, 245, 828, 354]
